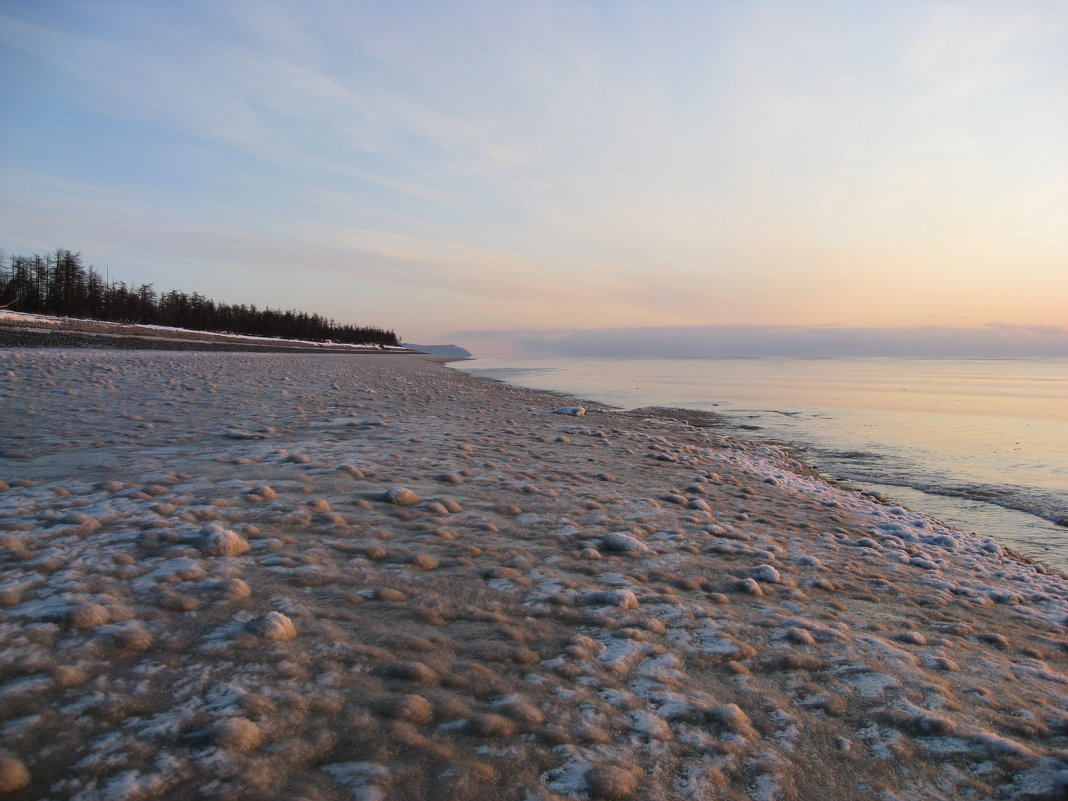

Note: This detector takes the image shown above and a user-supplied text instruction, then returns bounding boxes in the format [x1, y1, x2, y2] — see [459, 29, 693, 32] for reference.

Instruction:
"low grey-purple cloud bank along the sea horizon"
[449, 324, 1068, 359]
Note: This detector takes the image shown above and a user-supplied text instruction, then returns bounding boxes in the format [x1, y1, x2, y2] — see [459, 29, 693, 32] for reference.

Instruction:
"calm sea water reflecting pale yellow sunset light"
[452, 359, 1068, 570]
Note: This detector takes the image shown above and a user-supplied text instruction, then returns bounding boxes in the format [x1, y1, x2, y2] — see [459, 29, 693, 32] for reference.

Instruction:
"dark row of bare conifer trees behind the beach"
[0, 248, 399, 345]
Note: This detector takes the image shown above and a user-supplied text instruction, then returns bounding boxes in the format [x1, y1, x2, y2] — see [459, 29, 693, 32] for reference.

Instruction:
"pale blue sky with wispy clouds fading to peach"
[0, 0, 1068, 356]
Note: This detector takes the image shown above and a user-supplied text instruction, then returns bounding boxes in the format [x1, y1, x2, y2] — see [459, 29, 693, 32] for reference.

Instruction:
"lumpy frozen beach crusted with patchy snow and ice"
[0, 351, 1068, 801]
